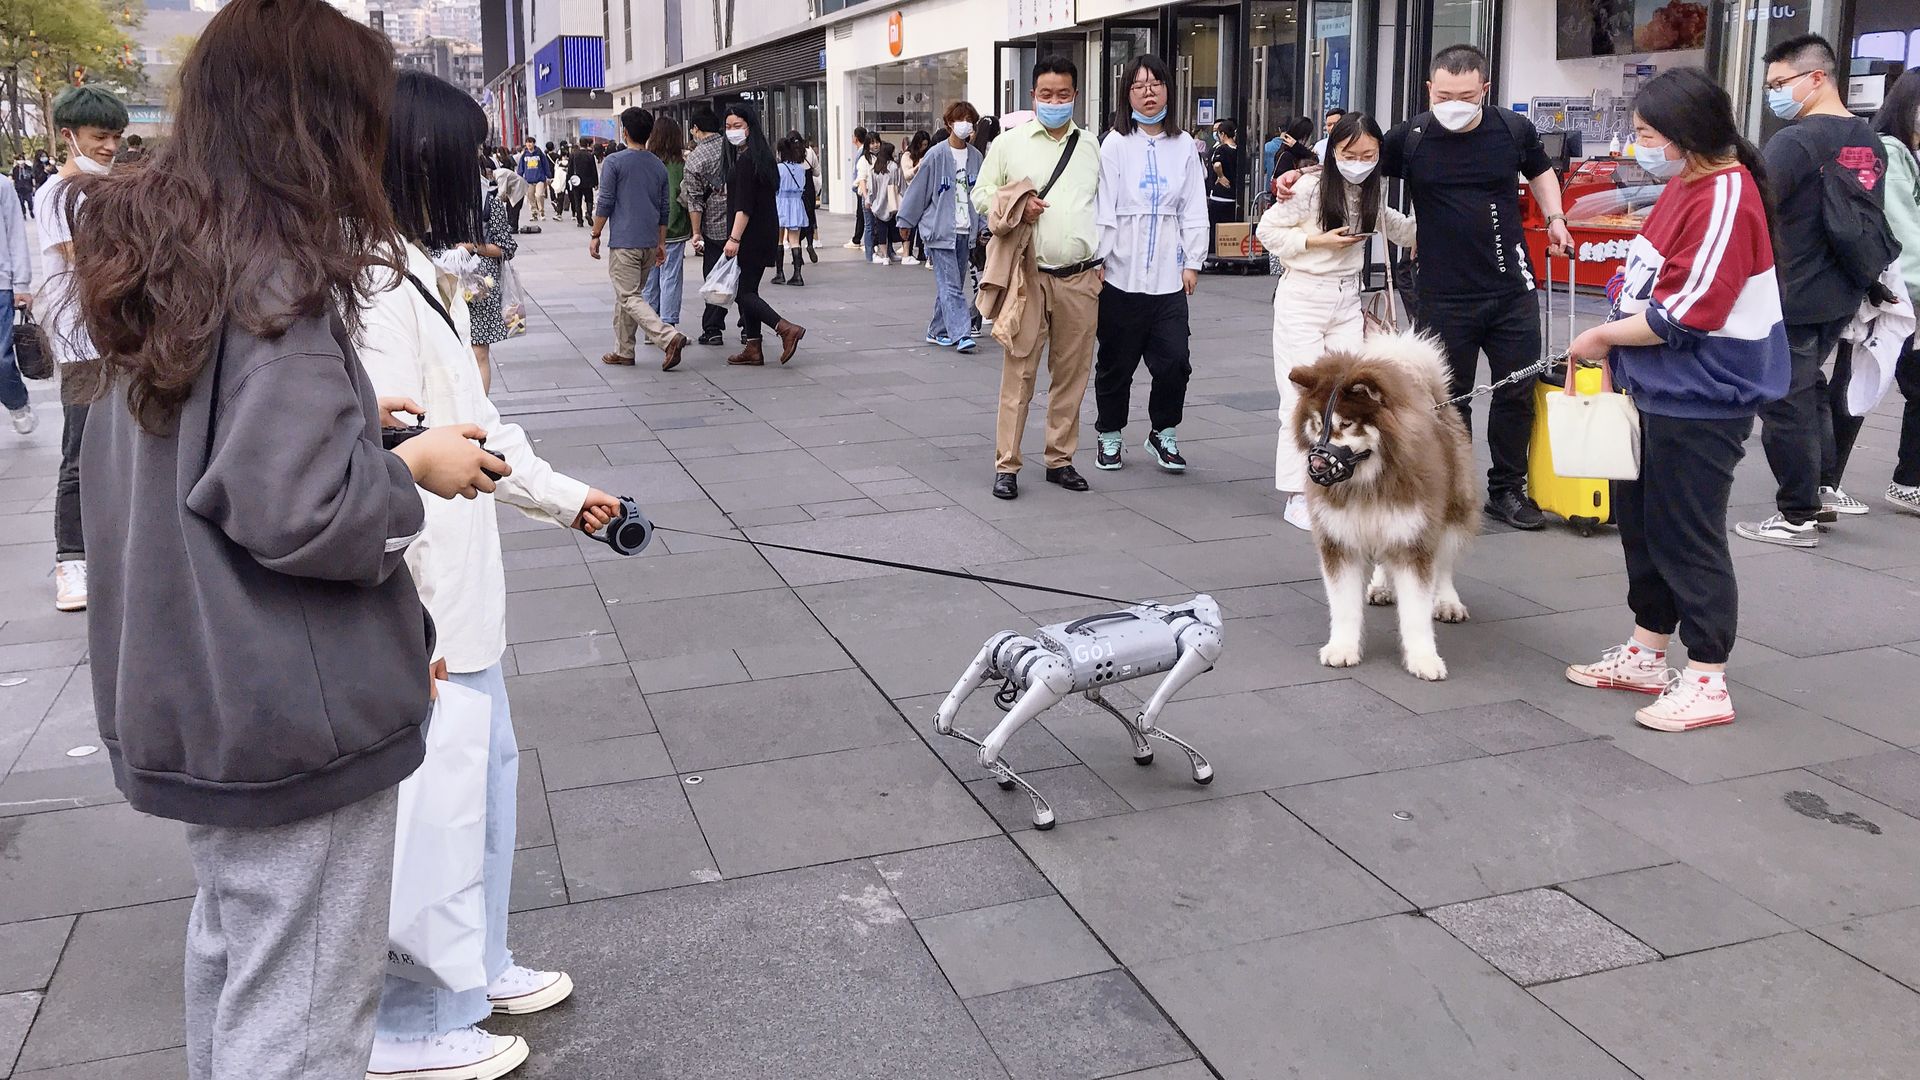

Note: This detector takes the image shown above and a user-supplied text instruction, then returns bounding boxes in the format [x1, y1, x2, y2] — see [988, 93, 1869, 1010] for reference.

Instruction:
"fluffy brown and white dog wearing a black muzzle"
[1288, 334, 1480, 678]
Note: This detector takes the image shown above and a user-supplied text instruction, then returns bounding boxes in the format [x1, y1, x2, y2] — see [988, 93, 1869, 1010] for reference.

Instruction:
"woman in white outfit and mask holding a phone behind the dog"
[1258, 113, 1413, 528]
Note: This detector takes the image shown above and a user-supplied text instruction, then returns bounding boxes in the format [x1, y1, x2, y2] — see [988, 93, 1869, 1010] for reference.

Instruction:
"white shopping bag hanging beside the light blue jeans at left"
[386, 682, 493, 990]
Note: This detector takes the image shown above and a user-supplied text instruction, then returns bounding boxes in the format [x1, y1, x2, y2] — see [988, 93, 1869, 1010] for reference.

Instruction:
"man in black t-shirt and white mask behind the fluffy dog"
[1380, 44, 1572, 528]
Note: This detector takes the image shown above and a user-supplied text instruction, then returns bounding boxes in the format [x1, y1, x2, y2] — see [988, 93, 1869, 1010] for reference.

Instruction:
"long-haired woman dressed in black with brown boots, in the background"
[726, 104, 806, 365]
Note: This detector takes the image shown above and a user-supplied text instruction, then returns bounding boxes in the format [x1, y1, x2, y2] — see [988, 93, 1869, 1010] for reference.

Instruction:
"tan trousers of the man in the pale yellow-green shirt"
[993, 271, 1100, 473]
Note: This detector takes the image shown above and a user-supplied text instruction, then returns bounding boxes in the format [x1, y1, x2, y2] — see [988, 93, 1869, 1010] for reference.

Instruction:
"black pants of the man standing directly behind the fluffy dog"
[1415, 292, 1542, 496]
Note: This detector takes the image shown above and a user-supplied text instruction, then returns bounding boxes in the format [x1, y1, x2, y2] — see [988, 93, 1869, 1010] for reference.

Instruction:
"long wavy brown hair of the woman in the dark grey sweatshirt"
[73, 0, 401, 434]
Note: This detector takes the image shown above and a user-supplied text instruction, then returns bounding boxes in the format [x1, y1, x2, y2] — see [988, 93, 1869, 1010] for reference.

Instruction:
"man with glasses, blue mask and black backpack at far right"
[1734, 35, 1887, 548]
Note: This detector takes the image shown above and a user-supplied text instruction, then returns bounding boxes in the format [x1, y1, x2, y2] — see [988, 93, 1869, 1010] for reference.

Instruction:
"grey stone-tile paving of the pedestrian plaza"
[0, 219, 1920, 1080]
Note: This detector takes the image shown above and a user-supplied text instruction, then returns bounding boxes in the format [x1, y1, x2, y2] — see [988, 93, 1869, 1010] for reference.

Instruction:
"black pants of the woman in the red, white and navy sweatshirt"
[1613, 413, 1753, 663]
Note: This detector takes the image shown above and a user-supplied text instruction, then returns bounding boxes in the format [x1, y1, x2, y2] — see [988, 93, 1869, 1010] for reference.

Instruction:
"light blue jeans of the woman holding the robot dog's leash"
[374, 663, 520, 1040]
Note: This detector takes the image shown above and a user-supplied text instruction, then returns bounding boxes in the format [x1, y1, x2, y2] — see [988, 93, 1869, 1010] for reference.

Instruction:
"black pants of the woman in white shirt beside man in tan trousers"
[1092, 284, 1192, 434]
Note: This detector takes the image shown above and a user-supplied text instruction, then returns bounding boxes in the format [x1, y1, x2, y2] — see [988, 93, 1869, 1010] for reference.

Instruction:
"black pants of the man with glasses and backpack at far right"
[1761, 319, 1849, 525]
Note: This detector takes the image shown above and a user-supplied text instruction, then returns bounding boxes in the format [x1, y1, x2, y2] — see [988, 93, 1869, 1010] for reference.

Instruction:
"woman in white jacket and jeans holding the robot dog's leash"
[359, 71, 618, 1080]
